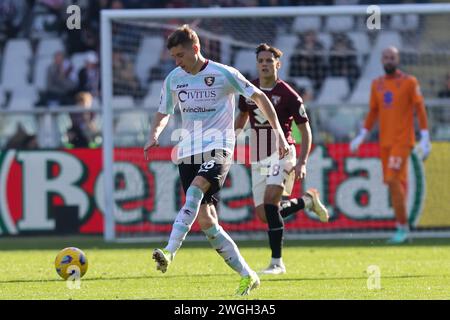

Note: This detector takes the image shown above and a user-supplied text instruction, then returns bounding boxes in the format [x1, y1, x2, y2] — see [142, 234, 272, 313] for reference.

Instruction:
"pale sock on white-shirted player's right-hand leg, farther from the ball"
[203, 225, 252, 277]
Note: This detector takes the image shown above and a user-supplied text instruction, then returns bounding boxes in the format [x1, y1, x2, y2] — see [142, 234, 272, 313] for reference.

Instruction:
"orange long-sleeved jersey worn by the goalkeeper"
[364, 71, 428, 147]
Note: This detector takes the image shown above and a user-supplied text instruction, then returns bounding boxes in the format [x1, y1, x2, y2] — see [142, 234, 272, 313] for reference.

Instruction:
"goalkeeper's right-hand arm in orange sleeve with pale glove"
[411, 78, 431, 159]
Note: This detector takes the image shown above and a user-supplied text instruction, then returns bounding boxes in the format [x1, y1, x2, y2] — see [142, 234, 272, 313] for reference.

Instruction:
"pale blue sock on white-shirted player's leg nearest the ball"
[165, 186, 204, 254]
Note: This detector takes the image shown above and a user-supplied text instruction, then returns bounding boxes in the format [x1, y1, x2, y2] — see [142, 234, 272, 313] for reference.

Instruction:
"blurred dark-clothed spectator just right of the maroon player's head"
[290, 30, 326, 92]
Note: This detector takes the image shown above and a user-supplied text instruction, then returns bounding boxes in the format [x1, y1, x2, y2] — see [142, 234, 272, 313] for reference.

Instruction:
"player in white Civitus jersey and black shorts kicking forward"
[144, 25, 289, 295]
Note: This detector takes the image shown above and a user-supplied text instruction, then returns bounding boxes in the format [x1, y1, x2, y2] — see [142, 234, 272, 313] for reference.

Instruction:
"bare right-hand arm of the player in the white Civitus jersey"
[251, 89, 289, 159]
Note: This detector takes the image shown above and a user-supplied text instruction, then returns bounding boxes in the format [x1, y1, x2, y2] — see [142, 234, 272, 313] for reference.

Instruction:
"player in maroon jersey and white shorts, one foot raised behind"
[235, 43, 328, 274]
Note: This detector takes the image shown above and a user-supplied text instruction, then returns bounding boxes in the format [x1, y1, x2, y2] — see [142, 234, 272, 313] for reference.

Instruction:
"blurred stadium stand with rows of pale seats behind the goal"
[0, 0, 448, 147]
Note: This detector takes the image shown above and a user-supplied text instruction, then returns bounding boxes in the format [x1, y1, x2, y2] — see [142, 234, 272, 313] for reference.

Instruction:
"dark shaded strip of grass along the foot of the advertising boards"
[0, 236, 450, 251]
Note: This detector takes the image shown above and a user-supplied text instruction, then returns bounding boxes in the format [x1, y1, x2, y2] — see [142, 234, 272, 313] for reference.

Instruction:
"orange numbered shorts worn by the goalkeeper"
[380, 145, 412, 184]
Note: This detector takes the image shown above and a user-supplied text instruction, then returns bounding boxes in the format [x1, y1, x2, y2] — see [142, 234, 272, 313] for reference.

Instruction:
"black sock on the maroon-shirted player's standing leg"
[264, 204, 284, 259]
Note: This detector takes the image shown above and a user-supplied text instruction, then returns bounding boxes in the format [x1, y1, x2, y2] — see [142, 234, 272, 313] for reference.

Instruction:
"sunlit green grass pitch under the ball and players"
[0, 237, 450, 300]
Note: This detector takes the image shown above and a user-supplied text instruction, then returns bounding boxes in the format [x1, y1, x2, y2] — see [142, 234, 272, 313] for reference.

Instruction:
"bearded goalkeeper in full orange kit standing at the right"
[350, 47, 431, 244]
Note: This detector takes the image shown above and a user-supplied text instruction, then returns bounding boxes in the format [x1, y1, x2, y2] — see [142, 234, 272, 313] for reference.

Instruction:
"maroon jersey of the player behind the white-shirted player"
[239, 79, 308, 161]
